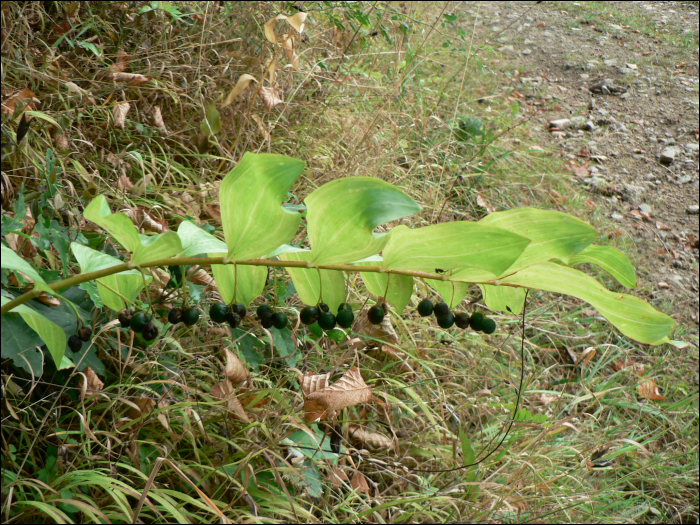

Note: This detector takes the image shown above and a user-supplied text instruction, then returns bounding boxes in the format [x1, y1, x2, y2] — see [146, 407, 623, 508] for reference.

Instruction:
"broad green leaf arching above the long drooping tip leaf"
[479, 208, 597, 275]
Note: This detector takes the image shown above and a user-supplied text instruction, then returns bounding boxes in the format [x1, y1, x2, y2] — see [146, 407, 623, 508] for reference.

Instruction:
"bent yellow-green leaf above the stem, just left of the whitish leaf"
[83, 195, 182, 264]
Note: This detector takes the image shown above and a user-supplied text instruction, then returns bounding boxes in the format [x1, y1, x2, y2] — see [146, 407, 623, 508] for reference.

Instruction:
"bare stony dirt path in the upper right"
[462, 2, 700, 333]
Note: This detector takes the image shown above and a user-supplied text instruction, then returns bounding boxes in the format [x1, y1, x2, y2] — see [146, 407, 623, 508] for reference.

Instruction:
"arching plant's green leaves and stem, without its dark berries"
[2, 149, 681, 363]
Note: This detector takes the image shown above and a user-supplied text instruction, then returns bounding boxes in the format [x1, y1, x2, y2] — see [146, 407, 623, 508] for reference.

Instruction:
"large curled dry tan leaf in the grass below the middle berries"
[304, 366, 372, 423]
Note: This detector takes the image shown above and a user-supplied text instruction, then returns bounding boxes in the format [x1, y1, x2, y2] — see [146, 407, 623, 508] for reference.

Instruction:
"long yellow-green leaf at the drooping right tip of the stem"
[501, 262, 676, 344]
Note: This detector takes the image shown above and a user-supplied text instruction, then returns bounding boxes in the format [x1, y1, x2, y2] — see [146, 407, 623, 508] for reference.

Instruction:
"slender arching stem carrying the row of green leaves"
[0, 257, 522, 315]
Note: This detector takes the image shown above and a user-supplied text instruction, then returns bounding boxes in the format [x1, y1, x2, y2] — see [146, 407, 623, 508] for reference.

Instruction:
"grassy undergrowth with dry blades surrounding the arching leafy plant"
[2, 2, 698, 523]
